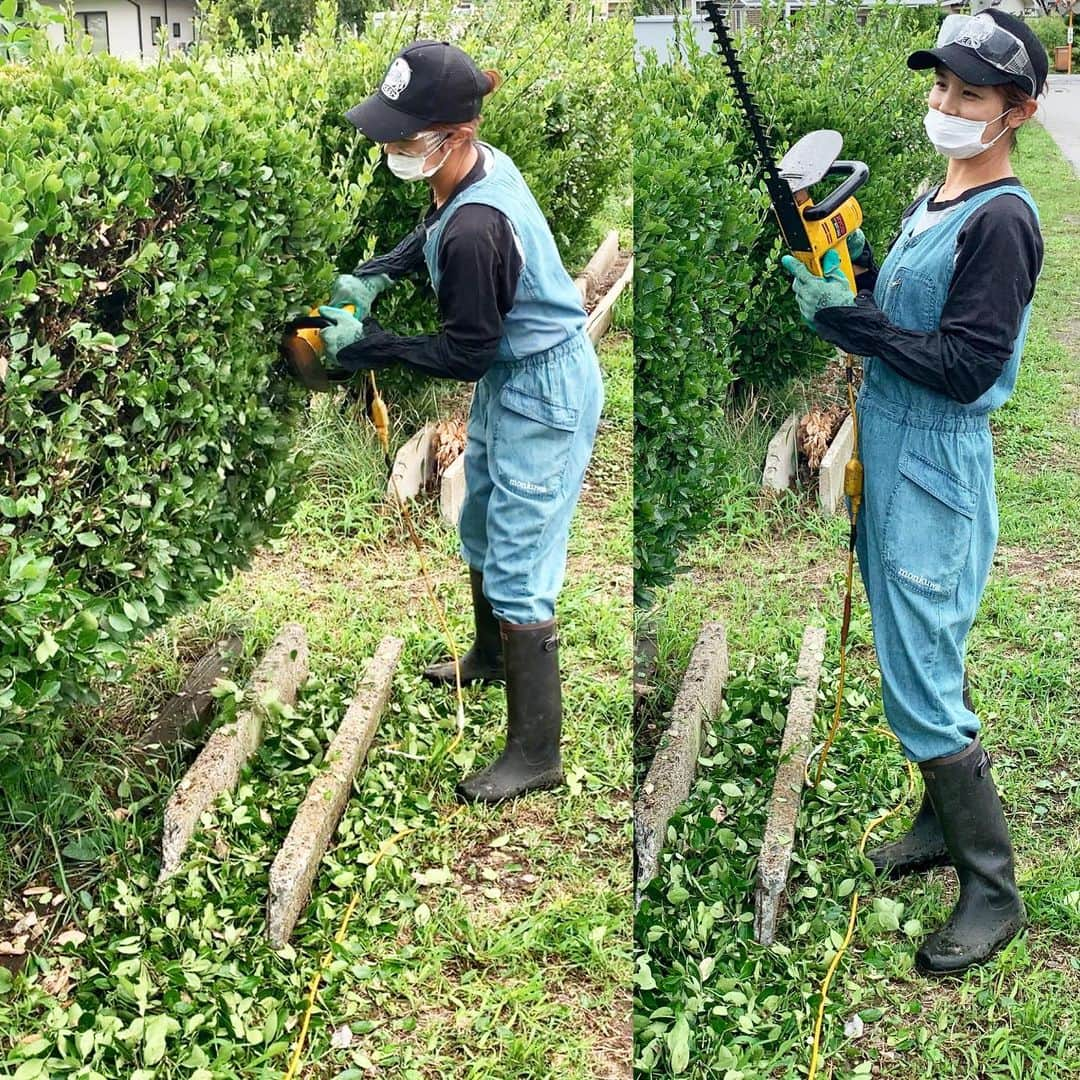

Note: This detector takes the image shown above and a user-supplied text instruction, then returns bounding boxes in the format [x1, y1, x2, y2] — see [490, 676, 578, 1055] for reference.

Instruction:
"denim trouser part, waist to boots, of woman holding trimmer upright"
[856, 407, 996, 761]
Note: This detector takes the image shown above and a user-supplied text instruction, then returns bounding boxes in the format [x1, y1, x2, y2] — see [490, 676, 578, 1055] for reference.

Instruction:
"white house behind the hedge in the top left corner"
[44, 0, 198, 60]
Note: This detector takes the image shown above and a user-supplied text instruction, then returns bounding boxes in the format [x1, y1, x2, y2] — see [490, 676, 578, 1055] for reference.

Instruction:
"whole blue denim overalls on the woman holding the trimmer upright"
[856, 187, 1038, 761]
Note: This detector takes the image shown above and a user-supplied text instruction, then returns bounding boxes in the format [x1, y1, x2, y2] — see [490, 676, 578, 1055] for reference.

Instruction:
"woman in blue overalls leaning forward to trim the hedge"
[320, 41, 603, 802]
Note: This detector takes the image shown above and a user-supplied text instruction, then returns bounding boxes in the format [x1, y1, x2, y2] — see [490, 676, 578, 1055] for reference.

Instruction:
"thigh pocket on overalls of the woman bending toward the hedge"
[494, 380, 581, 499]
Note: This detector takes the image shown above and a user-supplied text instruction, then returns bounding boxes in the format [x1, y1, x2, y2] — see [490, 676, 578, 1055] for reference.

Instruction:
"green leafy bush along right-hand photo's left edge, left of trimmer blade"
[634, 59, 766, 598]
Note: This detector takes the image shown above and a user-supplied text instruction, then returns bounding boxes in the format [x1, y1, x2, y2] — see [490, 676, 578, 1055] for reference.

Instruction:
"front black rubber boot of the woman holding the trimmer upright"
[915, 739, 1026, 975]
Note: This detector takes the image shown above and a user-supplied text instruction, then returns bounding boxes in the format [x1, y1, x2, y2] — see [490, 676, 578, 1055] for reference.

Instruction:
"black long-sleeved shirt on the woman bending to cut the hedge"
[338, 147, 524, 382]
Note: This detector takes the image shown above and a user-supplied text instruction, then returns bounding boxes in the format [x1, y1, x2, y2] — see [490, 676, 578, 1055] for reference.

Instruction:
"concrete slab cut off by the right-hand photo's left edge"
[634, 622, 728, 903]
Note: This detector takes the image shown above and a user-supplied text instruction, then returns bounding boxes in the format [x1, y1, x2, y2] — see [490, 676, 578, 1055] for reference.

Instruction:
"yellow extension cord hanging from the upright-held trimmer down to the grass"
[804, 353, 915, 1080]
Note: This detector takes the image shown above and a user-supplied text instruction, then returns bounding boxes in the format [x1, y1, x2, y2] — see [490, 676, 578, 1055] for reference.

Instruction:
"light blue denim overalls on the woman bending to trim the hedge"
[423, 145, 604, 625]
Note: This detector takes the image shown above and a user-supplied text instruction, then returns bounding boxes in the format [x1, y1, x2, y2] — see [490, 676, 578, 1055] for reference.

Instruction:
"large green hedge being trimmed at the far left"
[0, 42, 364, 745]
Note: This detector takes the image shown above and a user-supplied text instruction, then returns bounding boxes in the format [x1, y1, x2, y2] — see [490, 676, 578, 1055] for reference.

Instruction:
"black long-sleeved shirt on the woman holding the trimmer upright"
[814, 177, 1042, 404]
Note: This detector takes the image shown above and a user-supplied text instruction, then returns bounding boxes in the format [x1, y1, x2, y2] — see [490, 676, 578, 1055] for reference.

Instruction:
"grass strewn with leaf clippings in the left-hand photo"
[0, 302, 632, 1080]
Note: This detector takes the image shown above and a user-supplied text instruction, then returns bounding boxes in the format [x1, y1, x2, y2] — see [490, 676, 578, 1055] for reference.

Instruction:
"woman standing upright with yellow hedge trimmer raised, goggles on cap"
[784, 10, 1048, 974]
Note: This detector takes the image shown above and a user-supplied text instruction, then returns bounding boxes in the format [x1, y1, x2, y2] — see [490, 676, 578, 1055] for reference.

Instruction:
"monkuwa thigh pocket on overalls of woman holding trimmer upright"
[882, 450, 978, 599]
